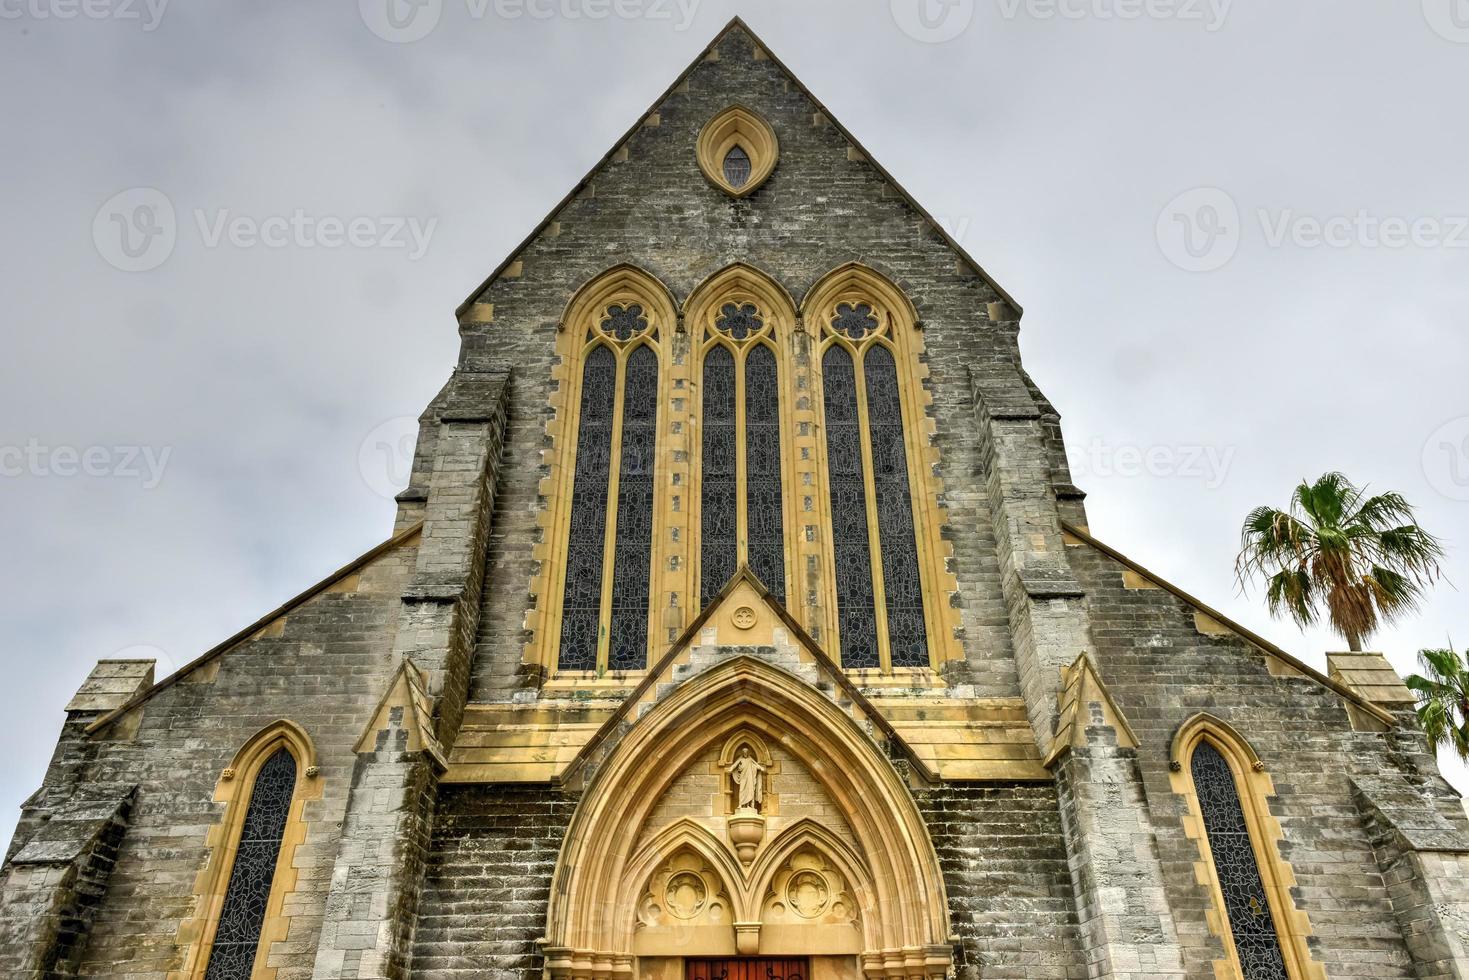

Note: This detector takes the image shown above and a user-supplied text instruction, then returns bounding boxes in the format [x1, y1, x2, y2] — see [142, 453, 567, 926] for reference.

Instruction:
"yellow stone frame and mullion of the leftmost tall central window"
[526, 264, 679, 673]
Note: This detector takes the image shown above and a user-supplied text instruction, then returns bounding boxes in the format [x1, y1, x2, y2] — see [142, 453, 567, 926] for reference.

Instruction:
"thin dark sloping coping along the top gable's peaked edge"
[454, 16, 1024, 320]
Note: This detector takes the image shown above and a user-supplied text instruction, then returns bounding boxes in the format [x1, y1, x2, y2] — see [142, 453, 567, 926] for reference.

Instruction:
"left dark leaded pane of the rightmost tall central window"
[821, 344, 880, 669]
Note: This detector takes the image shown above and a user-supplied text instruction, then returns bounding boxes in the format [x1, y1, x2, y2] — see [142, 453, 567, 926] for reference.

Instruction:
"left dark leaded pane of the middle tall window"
[699, 347, 739, 605]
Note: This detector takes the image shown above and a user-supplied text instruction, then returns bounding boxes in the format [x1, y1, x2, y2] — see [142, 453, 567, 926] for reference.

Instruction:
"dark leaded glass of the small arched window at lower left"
[204, 748, 295, 980]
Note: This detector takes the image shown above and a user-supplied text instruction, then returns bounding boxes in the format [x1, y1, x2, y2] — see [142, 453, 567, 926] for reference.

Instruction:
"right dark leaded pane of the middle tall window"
[745, 344, 786, 605]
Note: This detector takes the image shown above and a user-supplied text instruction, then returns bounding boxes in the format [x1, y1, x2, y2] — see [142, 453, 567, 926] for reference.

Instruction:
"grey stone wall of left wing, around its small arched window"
[7, 547, 413, 980]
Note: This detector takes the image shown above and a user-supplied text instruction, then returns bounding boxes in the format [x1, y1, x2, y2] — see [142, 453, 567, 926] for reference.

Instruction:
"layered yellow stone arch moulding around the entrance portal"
[545, 657, 949, 977]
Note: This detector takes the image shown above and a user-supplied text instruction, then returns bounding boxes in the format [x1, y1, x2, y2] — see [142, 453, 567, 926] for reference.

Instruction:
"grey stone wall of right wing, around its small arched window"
[1068, 545, 1413, 980]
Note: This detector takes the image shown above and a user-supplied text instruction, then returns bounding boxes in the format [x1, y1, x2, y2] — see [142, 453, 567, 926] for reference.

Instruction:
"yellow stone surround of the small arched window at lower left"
[167, 720, 322, 980]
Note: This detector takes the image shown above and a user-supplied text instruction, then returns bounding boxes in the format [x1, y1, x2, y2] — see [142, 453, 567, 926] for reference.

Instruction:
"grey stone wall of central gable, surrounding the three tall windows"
[460, 29, 1017, 701]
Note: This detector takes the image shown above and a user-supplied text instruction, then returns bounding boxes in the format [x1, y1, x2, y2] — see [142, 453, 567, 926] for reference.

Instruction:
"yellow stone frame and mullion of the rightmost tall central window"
[801, 263, 964, 671]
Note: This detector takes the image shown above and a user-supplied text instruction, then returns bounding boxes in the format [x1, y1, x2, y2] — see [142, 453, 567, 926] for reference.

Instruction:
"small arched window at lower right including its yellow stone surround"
[1172, 716, 1322, 980]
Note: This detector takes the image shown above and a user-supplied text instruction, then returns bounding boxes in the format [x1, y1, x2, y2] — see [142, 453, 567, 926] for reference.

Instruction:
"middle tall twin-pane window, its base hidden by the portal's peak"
[699, 291, 786, 605]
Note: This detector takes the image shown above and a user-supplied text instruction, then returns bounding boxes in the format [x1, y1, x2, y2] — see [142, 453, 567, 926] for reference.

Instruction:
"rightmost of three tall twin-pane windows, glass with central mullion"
[820, 285, 931, 669]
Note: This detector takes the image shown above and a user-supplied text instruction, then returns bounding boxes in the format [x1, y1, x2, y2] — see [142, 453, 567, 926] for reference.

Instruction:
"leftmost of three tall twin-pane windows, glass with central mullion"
[557, 295, 661, 671]
